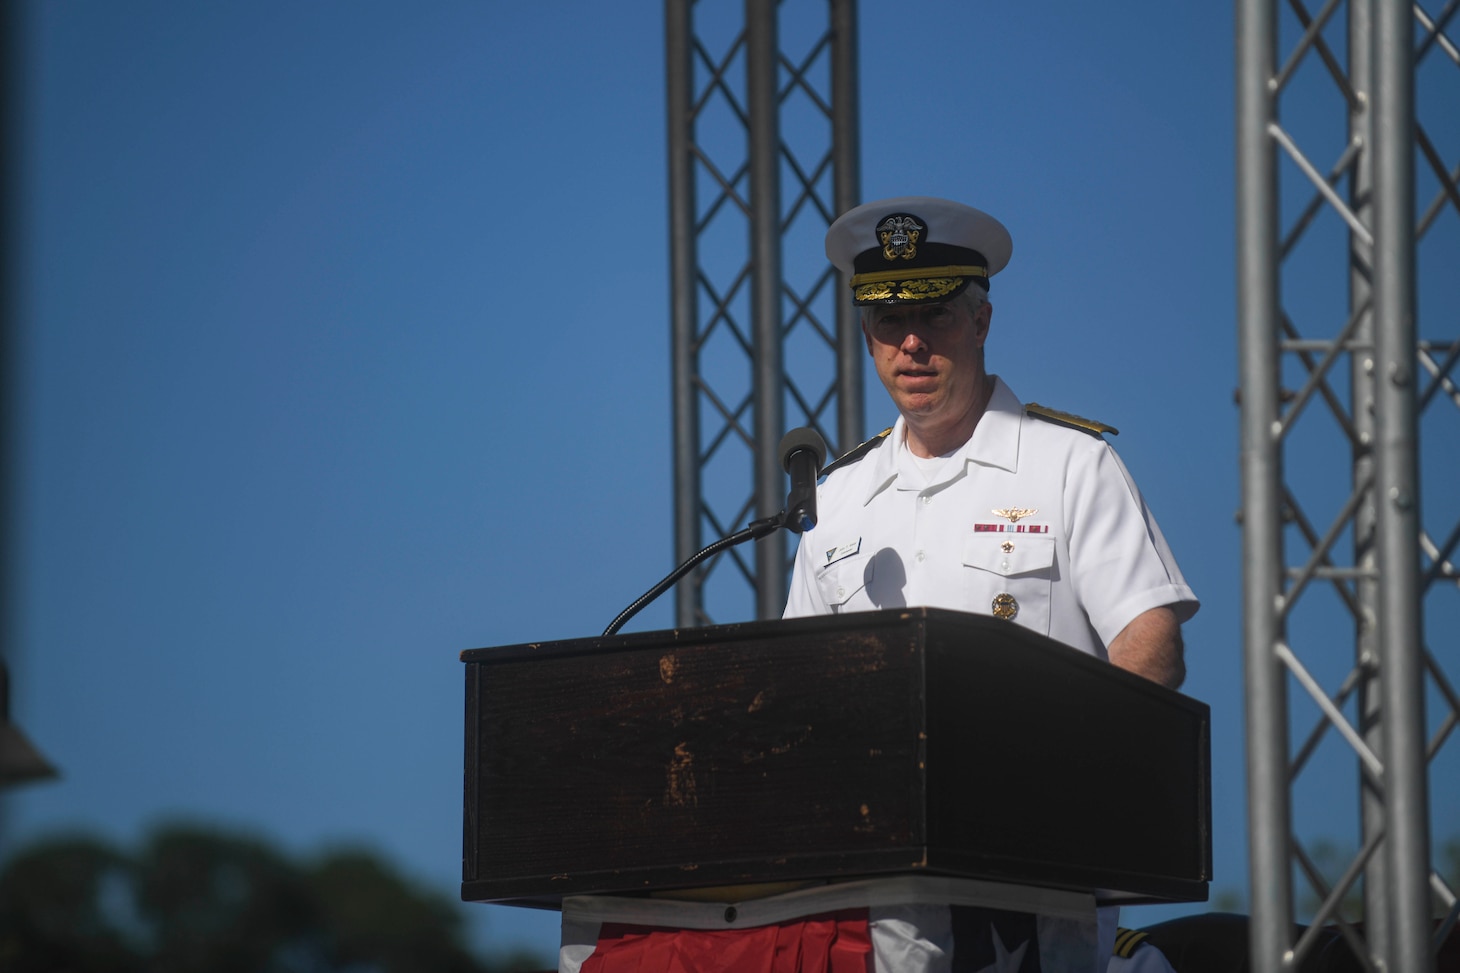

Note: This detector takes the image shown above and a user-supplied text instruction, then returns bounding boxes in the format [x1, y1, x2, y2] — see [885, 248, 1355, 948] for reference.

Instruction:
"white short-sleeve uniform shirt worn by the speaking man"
[785, 377, 1199, 657]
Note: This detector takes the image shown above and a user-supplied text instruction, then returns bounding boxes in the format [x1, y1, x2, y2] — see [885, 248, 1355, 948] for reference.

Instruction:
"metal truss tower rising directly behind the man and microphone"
[664, 0, 861, 625]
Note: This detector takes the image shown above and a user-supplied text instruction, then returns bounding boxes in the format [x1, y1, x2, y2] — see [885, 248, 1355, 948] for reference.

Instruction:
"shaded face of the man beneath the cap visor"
[861, 302, 993, 422]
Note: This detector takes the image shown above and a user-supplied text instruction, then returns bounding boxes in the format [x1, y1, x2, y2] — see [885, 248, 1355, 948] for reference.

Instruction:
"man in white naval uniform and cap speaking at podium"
[785, 196, 1197, 688]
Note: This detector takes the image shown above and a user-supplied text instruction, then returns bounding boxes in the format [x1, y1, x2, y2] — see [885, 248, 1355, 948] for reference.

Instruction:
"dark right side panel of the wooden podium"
[927, 613, 1212, 903]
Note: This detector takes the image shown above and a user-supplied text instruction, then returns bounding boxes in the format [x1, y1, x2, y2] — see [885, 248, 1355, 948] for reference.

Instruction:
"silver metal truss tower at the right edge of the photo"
[1237, 0, 1460, 973]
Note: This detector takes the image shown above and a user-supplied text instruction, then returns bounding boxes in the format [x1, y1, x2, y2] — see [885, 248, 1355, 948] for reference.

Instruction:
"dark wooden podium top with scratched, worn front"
[461, 608, 1212, 906]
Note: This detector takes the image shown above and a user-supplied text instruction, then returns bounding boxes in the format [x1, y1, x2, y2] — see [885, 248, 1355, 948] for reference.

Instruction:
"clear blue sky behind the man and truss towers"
[4, 0, 1460, 947]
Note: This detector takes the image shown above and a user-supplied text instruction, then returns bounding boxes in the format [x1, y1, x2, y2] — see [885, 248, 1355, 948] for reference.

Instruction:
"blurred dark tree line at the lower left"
[0, 825, 555, 973]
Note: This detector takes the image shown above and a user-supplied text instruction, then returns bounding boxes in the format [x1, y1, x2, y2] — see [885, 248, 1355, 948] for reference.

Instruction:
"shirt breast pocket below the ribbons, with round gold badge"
[964, 533, 1059, 636]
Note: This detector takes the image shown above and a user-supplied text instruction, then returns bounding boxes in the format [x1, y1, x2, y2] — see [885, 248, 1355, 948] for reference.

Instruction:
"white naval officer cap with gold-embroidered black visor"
[826, 196, 1013, 304]
